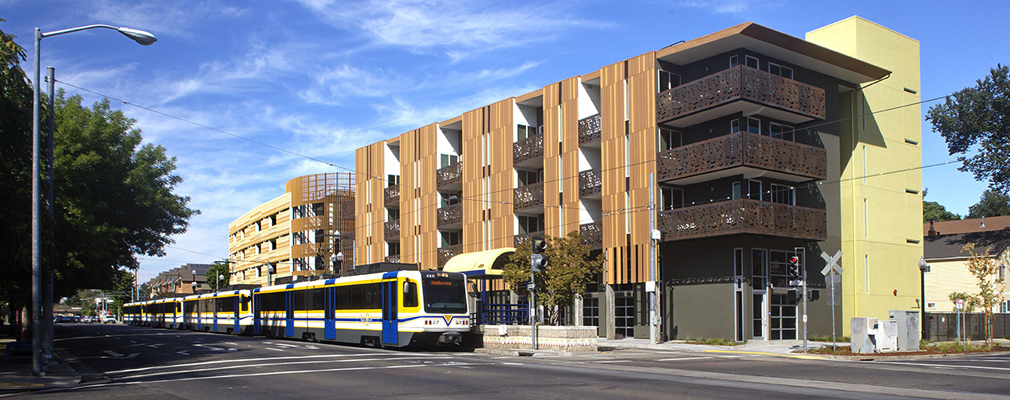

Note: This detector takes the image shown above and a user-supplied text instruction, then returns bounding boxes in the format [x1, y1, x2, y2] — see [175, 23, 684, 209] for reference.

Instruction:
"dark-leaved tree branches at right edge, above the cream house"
[926, 65, 1010, 193]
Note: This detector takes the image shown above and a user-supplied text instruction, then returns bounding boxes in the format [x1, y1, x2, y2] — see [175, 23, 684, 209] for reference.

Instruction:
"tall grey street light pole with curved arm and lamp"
[31, 24, 158, 376]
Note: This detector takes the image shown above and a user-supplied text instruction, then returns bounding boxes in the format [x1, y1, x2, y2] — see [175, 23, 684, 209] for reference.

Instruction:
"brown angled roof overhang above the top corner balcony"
[655, 22, 891, 84]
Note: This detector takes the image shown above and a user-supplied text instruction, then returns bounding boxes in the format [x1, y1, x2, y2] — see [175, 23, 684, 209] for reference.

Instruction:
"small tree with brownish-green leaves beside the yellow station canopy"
[502, 231, 603, 325]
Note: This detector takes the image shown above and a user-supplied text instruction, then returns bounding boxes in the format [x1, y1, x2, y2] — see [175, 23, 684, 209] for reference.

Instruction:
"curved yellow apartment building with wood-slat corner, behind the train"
[228, 173, 355, 286]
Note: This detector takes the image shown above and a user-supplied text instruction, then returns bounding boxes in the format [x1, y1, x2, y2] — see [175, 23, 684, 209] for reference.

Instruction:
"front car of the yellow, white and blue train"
[253, 271, 470, 347]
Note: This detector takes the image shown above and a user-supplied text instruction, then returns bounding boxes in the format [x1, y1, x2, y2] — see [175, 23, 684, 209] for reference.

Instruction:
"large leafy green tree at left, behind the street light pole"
[0, 20, 199, 315]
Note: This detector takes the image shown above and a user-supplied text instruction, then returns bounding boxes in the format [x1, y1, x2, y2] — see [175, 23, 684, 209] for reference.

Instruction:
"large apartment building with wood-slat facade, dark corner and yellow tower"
[355, 17, 922, 340]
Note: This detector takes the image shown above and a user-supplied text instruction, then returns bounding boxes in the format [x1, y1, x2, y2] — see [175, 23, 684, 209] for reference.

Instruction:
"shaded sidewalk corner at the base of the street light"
[0, 325, 81, 396]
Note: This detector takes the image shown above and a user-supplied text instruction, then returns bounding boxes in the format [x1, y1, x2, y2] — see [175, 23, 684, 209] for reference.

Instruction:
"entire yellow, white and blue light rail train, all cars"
[123, 271, 470, 347]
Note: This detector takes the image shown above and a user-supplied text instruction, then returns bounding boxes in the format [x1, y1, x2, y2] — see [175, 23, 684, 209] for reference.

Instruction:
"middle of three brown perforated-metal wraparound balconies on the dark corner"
[655, 131, 827, 185]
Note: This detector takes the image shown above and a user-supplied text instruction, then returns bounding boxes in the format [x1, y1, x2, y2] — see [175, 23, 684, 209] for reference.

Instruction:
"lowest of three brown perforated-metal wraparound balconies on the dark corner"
[657, 199, 827, 241]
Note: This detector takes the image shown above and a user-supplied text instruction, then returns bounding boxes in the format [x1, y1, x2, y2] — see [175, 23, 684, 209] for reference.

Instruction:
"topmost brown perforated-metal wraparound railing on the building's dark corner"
[655, 66, 826, 123]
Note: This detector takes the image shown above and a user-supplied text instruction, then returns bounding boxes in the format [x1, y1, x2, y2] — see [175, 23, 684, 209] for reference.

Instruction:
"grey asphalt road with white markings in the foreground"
[9, 324, 1010, 400]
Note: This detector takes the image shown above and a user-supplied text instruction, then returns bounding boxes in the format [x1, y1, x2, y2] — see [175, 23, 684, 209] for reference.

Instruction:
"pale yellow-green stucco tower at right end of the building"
[806, 16, 922, 334]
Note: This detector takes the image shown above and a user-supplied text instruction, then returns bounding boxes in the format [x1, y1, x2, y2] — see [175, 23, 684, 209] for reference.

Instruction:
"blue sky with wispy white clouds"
[0, 0, 1010, 282]
